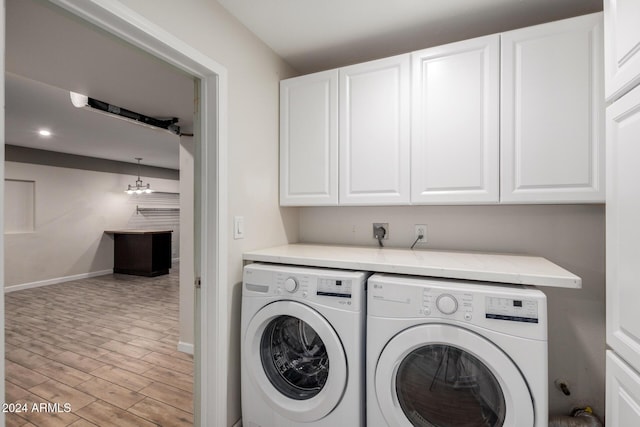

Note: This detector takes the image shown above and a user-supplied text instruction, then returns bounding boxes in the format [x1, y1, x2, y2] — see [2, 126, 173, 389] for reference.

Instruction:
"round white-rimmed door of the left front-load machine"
[243, 301, 348, 422]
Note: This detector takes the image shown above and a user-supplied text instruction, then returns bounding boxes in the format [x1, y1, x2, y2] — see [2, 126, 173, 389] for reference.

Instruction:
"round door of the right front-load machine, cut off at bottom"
[374, 324, 534, 427]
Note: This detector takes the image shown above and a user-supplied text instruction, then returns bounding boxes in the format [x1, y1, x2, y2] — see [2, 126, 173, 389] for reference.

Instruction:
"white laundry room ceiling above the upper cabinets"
[218, 0, 602, 74]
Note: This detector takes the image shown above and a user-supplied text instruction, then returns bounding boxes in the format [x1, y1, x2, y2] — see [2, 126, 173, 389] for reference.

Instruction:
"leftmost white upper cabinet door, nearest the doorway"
[280, 70, 338, 206]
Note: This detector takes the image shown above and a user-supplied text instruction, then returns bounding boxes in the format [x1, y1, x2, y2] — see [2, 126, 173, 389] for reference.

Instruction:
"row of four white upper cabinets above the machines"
[280, 13, 604, 206]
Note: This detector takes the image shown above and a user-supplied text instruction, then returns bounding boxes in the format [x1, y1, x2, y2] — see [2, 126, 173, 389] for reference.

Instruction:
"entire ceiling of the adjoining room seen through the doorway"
[5, 0, 194, 169]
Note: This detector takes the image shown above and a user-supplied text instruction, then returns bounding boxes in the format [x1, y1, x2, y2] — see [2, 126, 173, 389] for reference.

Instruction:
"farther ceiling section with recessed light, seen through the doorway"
[5, 73, 180, 169]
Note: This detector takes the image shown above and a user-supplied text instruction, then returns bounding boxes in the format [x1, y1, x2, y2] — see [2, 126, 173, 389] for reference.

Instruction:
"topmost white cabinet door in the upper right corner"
[604, 0, 640, 101]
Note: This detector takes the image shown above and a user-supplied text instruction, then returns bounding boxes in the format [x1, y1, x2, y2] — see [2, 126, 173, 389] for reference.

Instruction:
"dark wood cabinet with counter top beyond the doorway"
[106, 230, 172, 277]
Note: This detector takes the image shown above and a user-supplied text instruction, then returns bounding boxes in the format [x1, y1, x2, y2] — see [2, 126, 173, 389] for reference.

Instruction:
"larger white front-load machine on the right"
[366, 274, 548, 427]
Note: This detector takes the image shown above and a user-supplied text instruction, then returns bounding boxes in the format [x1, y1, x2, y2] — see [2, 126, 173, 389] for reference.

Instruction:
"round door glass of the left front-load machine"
[260, 316, 329, 400]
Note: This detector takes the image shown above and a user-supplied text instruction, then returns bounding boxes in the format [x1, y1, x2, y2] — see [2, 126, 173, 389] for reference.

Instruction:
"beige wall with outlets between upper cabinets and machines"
[300, 205, 605, 415]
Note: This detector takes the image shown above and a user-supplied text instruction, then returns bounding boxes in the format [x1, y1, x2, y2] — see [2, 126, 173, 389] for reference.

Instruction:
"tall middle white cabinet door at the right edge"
[606, 83, 640, 371]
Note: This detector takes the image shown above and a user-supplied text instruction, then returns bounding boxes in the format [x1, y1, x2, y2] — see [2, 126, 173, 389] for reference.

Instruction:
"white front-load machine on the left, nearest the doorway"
[241, 264, 368, 427]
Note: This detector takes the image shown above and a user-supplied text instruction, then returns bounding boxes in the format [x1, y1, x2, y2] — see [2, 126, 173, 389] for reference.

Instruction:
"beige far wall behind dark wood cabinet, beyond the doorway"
[4, 162, 178, 288]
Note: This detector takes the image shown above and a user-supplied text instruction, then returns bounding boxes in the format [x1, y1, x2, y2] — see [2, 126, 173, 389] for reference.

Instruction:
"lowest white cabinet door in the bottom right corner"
[605, 350, 640, 427]
